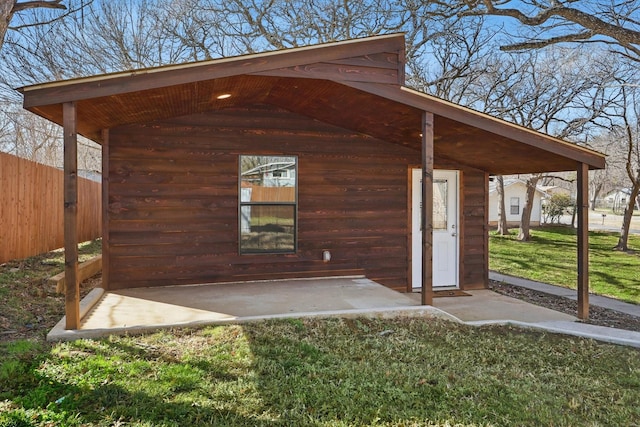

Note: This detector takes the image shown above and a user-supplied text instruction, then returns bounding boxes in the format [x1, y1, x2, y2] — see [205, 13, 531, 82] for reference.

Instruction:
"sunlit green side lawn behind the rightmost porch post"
[489, 226, 640, 304]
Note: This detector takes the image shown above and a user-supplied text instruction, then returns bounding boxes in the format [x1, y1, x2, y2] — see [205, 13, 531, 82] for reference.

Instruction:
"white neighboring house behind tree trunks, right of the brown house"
[489, 178, 547, 227]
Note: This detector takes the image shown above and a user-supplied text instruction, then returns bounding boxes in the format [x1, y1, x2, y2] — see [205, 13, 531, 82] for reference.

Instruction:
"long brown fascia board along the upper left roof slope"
[19, 34, 404, 108]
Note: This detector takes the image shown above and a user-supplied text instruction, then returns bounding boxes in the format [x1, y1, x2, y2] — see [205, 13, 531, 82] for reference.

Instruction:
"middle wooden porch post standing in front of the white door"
[420, 111, 433, 305]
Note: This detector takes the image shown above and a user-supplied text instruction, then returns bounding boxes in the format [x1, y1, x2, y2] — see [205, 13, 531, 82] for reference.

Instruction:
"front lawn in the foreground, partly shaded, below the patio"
[0, 319, 640, 426]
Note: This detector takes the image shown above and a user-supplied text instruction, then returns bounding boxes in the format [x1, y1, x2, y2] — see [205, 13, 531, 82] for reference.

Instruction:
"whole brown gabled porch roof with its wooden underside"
[21, 34, 604, 175]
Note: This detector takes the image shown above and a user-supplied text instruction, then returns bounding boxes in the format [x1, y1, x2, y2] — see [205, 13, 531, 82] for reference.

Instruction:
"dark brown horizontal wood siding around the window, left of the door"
[107, 106, 420, 289]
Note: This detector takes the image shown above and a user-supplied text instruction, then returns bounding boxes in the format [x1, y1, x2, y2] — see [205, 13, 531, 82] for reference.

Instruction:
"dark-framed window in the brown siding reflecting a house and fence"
[238, 155, 298, 254]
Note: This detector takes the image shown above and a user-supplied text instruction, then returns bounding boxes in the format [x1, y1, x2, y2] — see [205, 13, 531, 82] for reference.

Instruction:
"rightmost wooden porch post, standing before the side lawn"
[577, 163, 589, 320]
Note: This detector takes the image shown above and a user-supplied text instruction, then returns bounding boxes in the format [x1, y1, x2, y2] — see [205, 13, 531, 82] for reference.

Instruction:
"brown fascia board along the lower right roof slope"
[336, 81, 605, 169]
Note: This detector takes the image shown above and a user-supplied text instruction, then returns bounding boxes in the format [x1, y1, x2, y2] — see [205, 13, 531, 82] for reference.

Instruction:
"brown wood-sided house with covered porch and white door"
[21, 34, 604, 329]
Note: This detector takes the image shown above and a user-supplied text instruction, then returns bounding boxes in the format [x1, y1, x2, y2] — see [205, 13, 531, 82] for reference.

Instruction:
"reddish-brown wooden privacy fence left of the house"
[0, 153, 102, 263]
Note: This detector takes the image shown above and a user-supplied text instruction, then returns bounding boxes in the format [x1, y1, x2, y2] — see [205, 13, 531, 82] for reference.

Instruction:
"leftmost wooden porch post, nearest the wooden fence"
[62, 102, 80, 329]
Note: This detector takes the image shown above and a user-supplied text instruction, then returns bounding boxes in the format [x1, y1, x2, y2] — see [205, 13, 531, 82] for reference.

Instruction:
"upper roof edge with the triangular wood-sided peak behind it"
[18, 34, 405, 108]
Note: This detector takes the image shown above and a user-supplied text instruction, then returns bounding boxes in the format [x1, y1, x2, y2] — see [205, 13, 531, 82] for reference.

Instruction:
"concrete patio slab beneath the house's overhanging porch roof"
[47, 276, 575, 341]
